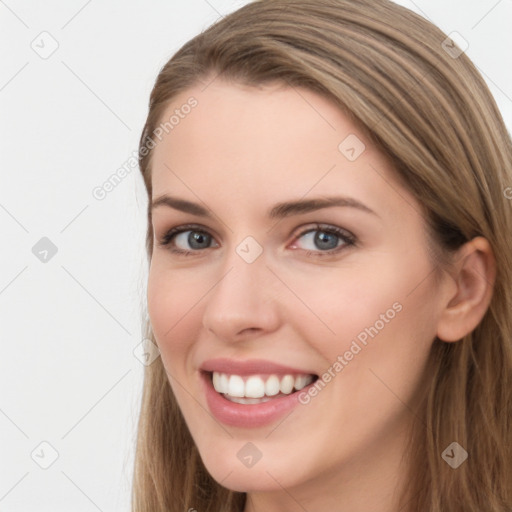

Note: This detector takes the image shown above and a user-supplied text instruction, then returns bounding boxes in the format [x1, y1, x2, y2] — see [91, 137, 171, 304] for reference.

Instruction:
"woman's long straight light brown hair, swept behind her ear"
[132, 0, 512, 512]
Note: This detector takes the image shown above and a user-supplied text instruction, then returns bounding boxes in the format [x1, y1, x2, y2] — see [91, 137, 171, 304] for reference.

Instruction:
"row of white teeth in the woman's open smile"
[212, 372, 314, 404]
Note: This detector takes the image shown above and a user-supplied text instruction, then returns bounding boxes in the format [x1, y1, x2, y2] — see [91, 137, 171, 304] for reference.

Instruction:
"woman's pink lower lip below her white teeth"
[201, 372, 314, 428]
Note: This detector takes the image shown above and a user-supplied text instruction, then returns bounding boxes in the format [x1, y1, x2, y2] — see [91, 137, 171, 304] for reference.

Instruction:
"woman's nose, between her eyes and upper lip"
[203, 246, 279, 342]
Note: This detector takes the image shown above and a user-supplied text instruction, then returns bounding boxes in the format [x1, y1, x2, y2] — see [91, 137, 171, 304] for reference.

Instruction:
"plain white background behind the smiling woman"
[0, 0, 512, 512]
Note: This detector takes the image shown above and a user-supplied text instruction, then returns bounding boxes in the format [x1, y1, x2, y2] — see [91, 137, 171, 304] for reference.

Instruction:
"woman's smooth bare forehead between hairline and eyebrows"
[152, 80, 408, 216]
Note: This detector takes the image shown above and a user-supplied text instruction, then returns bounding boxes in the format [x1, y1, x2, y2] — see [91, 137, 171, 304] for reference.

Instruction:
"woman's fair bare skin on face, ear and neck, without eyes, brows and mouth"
[148, 79, 493, 512]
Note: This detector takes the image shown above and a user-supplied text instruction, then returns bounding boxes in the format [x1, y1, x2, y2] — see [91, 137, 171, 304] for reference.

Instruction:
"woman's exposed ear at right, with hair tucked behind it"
[437, 236, 496, 342]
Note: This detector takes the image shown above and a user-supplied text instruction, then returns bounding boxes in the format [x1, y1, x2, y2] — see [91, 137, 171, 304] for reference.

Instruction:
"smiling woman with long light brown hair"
[133, 0, 512, 512]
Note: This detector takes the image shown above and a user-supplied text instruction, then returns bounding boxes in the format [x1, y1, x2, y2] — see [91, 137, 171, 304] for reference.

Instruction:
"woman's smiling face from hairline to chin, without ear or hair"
[148, 79, 448, 500]
